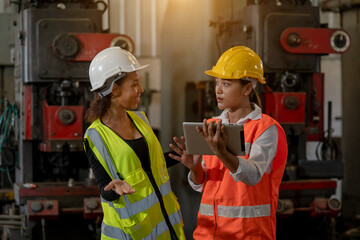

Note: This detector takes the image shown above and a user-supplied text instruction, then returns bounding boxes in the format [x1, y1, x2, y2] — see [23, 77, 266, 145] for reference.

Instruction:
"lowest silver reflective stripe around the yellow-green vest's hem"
[101, 210, 181, 240]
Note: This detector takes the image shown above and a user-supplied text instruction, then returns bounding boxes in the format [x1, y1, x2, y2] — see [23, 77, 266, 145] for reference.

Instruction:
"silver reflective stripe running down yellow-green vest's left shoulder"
[87, 128, 119, 179]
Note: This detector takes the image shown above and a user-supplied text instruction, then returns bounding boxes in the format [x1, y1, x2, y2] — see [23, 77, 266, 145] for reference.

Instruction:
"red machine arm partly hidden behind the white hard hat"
[52, 33, 134, 61]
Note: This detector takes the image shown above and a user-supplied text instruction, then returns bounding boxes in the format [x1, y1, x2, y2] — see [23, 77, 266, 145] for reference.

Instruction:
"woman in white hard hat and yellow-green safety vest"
[84, 47, 185, 240]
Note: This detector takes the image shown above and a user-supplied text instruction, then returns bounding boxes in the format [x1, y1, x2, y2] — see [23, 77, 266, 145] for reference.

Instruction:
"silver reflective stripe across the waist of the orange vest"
[199, 203, 271, 218]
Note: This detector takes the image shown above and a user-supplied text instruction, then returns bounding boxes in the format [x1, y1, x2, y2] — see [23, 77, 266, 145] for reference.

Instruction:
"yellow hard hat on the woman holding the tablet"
[205, 46, 266, 84]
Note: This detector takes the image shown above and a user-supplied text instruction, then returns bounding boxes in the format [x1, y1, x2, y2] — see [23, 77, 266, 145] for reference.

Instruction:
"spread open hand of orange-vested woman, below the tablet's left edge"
[169, 136, 202, 170]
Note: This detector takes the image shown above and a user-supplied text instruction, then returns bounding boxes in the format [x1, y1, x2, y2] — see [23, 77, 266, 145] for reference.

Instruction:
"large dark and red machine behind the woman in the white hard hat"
[0, 0, 134, 240]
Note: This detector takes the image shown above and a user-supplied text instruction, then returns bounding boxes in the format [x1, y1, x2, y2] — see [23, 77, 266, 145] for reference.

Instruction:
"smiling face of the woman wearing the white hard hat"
[113, 71, 144, 109]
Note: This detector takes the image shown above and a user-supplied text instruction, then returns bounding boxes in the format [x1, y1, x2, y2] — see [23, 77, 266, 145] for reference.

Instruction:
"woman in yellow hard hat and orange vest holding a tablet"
[170, 46, 287, 240]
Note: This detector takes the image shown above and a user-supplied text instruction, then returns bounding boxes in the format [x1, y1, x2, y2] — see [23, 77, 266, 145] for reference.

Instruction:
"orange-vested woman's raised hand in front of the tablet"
[196, 119, 227, 156]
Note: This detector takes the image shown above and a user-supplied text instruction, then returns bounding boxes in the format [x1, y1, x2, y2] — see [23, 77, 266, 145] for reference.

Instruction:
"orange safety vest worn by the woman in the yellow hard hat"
[193, 114, 287, 240]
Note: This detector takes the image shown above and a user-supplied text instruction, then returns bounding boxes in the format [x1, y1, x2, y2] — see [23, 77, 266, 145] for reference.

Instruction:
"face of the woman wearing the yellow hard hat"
[215, 78, 251, 109]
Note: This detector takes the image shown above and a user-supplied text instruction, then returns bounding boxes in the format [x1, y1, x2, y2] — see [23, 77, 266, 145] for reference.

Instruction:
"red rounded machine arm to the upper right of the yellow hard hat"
[280, 28, 350, 54]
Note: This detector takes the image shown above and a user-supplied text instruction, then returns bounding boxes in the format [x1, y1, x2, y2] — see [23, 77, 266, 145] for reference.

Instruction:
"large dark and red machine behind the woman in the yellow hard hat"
[186, 0, 350, 239]
